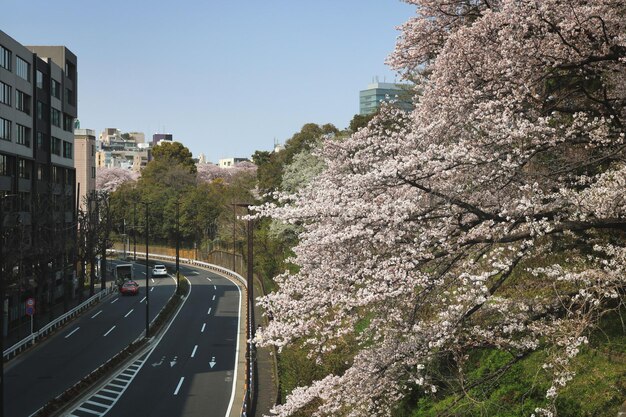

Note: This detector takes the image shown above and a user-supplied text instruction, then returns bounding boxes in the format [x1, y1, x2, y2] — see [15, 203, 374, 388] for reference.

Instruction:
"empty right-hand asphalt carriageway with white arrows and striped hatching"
[68, 266, 242, 417]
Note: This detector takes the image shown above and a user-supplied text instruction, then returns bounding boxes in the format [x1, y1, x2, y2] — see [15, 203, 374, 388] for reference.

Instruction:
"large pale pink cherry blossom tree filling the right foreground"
[256, 0, 626, 416]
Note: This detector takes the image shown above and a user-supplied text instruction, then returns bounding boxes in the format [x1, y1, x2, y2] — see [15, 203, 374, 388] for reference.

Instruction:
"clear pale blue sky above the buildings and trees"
[0, 0, 415, 162]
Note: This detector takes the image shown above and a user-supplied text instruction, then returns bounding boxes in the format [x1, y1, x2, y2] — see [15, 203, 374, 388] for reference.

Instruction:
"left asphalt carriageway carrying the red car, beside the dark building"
[4, 265, 176, 417]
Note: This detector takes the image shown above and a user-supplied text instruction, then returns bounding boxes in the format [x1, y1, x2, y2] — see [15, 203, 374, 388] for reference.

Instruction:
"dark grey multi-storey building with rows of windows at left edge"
[0, 31, 78, 321]
